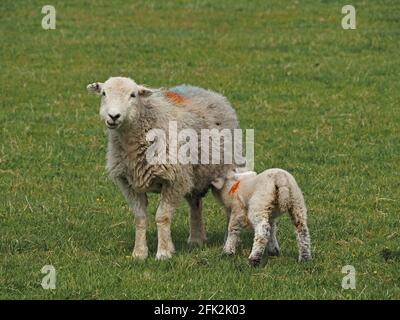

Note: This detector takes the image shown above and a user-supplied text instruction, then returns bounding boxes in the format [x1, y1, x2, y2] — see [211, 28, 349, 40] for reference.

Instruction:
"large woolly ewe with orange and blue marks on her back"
[87, 77, 239, 259]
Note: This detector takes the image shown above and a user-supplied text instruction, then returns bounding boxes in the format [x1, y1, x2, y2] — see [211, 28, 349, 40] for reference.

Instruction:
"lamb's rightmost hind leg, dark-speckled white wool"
[289, 204, 311, 261]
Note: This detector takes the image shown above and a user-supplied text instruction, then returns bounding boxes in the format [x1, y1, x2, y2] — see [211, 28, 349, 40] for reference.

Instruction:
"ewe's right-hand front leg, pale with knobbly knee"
[156, 189, 179, 260]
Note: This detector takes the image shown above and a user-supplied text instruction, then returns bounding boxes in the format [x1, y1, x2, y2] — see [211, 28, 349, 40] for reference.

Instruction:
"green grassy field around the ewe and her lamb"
[0, 0, 400, 299]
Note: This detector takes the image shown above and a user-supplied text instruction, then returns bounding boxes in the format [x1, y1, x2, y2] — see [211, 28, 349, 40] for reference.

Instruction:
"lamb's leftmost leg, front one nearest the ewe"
[224, 206, 246, 255]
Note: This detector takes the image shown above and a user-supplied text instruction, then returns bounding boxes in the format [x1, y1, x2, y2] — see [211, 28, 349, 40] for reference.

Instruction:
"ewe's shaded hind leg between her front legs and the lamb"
[186, 197, 206, 245]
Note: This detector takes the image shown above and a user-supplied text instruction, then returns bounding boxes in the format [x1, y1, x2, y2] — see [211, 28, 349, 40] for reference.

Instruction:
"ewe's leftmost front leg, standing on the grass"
[116, 178, 148, 259]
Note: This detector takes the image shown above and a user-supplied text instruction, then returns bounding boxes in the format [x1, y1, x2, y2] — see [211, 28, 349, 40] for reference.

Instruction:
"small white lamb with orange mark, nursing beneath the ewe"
[212, 169, 311, 266]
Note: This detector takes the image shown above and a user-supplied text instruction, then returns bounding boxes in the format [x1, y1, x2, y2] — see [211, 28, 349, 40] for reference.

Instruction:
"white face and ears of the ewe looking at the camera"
[87, 77, 153, 129]
